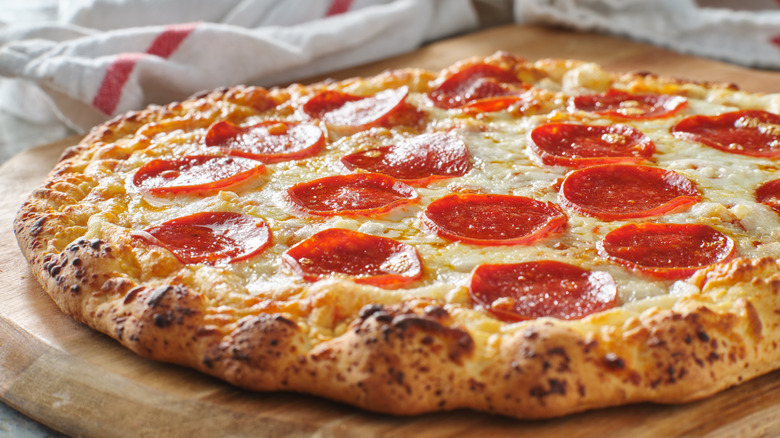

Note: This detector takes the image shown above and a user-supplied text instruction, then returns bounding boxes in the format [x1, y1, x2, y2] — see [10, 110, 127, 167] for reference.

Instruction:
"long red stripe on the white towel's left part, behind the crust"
[92, 23, 197, 115]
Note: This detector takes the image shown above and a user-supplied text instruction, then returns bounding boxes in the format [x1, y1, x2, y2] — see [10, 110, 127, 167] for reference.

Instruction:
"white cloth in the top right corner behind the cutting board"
[514, 0, 780, 69]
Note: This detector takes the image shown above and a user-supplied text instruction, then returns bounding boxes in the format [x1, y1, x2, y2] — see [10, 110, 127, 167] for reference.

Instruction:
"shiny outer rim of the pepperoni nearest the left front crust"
[131, 211, 273, 265]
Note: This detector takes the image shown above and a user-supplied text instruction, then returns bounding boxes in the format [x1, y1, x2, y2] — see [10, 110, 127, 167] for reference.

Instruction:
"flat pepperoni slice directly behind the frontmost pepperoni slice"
[423, 194, 567, 245]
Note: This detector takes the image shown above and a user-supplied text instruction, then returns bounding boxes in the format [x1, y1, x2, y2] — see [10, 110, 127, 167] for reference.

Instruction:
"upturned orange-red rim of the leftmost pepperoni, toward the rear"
[133, 155, 267, 196]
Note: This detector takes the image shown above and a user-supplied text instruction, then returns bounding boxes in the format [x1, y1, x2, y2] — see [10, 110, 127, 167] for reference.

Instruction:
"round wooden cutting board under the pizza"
[0, 26, 780, 438]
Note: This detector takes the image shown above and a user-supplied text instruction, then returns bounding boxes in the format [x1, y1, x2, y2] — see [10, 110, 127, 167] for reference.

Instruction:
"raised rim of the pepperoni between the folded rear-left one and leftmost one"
[204, 120, 325, 164]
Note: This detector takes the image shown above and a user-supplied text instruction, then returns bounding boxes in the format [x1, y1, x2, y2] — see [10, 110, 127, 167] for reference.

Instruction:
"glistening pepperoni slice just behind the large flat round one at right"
[530, 123, 655, 167]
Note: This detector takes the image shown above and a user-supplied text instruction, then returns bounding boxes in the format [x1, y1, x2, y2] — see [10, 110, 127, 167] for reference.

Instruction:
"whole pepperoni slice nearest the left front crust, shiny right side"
[135, 212, 271, 265]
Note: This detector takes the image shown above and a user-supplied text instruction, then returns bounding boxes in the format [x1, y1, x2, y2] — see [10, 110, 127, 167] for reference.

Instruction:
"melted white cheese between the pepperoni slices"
[90, 64, 780, 328]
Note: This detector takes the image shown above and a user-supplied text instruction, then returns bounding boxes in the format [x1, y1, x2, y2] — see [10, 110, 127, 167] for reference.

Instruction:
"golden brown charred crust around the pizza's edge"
[15, 53, 780, 418]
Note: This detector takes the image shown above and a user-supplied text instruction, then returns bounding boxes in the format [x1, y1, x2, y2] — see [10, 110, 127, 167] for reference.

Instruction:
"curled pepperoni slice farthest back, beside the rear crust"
[429, 64, 523, 111]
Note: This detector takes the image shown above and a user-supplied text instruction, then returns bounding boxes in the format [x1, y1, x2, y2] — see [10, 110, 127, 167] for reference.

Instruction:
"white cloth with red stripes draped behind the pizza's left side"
[0, 0, 478, 133]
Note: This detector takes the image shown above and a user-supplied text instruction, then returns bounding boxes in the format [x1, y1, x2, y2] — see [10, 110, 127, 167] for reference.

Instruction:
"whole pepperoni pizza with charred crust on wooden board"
[14, 52, 780, 418]
